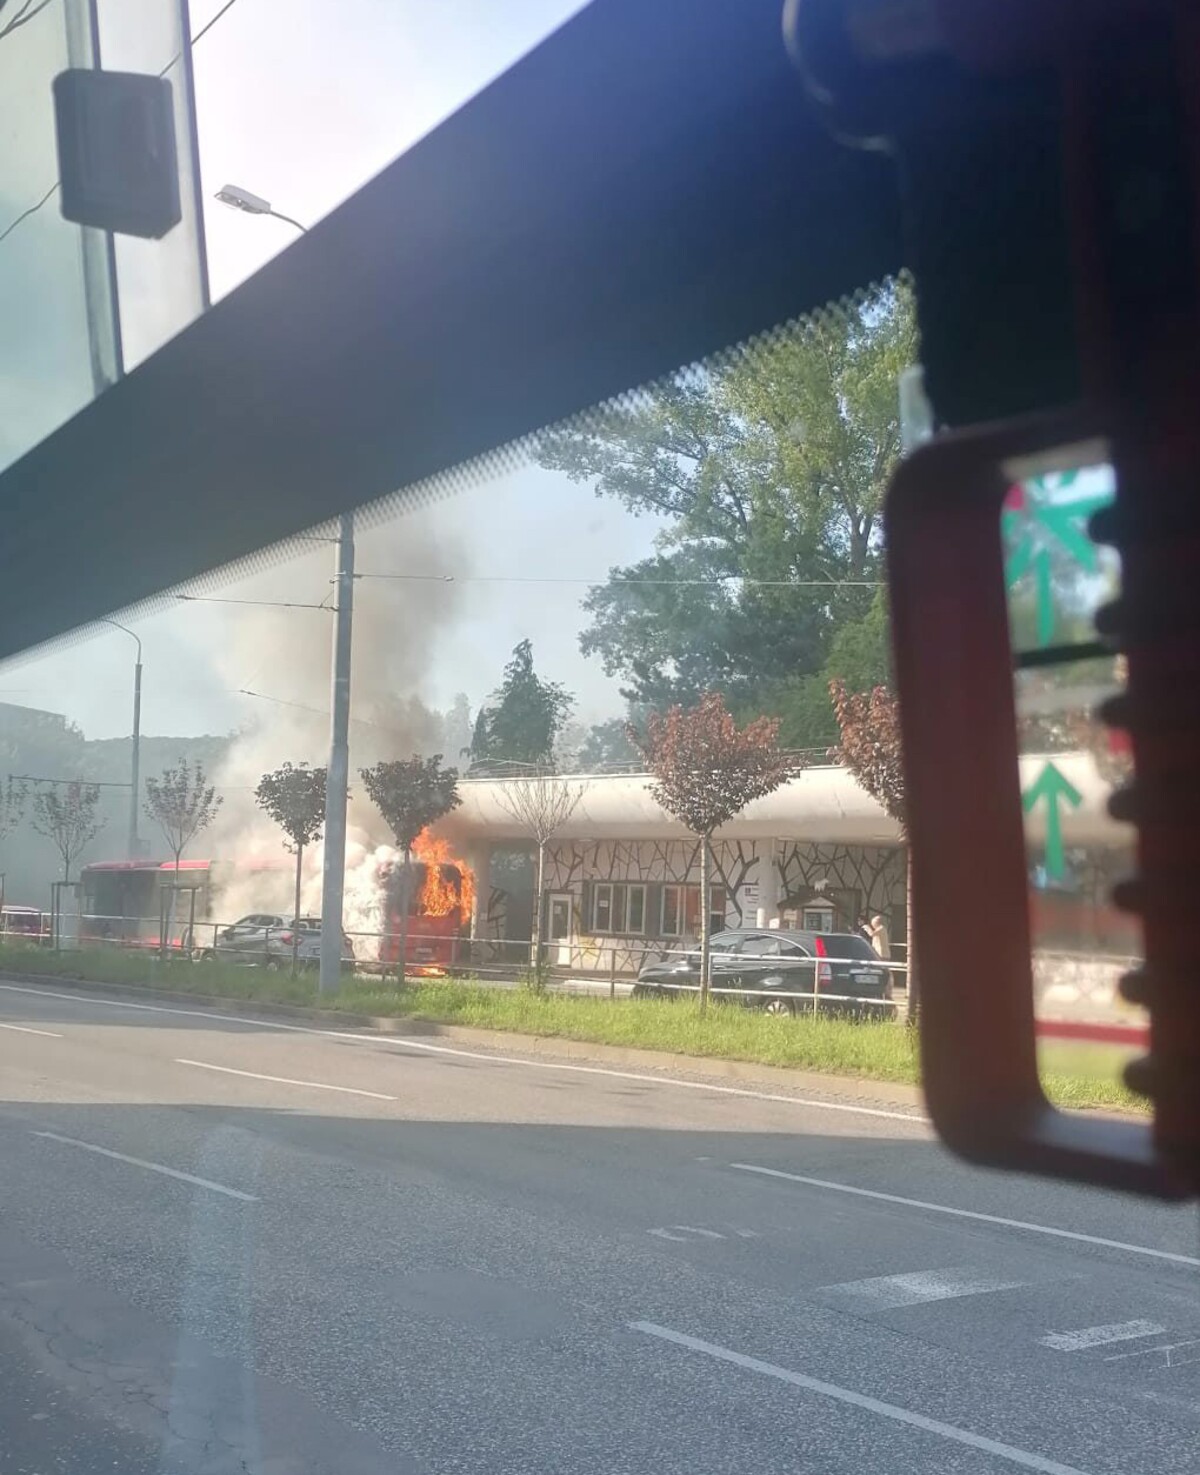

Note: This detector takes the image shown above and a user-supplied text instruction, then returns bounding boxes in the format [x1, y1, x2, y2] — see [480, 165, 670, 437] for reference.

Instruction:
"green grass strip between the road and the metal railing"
[0, 947, 1144, 1111]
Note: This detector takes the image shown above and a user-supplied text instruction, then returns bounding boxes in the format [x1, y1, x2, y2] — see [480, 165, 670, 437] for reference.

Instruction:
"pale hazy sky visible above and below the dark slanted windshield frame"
[0, 0, 656, 738]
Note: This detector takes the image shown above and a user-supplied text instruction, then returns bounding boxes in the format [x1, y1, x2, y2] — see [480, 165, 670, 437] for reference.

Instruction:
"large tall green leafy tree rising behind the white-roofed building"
[538, 285, 915, 712]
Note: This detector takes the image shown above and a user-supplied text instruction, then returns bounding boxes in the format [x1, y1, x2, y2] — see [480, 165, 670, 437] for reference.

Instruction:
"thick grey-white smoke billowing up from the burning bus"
[206, 513, 464, 956]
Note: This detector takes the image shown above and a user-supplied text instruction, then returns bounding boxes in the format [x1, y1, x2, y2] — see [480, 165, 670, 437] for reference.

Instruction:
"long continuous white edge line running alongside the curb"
[0, 984, 929, 1127]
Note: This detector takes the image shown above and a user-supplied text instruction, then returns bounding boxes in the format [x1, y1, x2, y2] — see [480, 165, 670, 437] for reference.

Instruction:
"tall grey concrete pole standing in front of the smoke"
[320, 512, 354, 994]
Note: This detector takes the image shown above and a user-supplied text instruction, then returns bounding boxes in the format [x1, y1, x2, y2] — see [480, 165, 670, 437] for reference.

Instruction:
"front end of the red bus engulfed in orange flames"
[379, 830, 475, 976]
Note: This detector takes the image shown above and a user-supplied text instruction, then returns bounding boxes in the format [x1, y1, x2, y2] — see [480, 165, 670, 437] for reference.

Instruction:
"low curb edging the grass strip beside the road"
[0, 972, 926, 1121]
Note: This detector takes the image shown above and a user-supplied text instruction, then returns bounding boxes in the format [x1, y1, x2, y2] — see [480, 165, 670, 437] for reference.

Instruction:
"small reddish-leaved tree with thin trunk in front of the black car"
[629, 692, 798, 1012]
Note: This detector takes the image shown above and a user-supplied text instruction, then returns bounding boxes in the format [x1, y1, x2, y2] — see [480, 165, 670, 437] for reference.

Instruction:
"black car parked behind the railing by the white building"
[634, 928, 893, 1016]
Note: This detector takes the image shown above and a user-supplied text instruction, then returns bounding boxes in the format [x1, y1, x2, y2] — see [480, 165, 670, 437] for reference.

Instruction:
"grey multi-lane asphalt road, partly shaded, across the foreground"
[0, 982, 1200, 1475]
